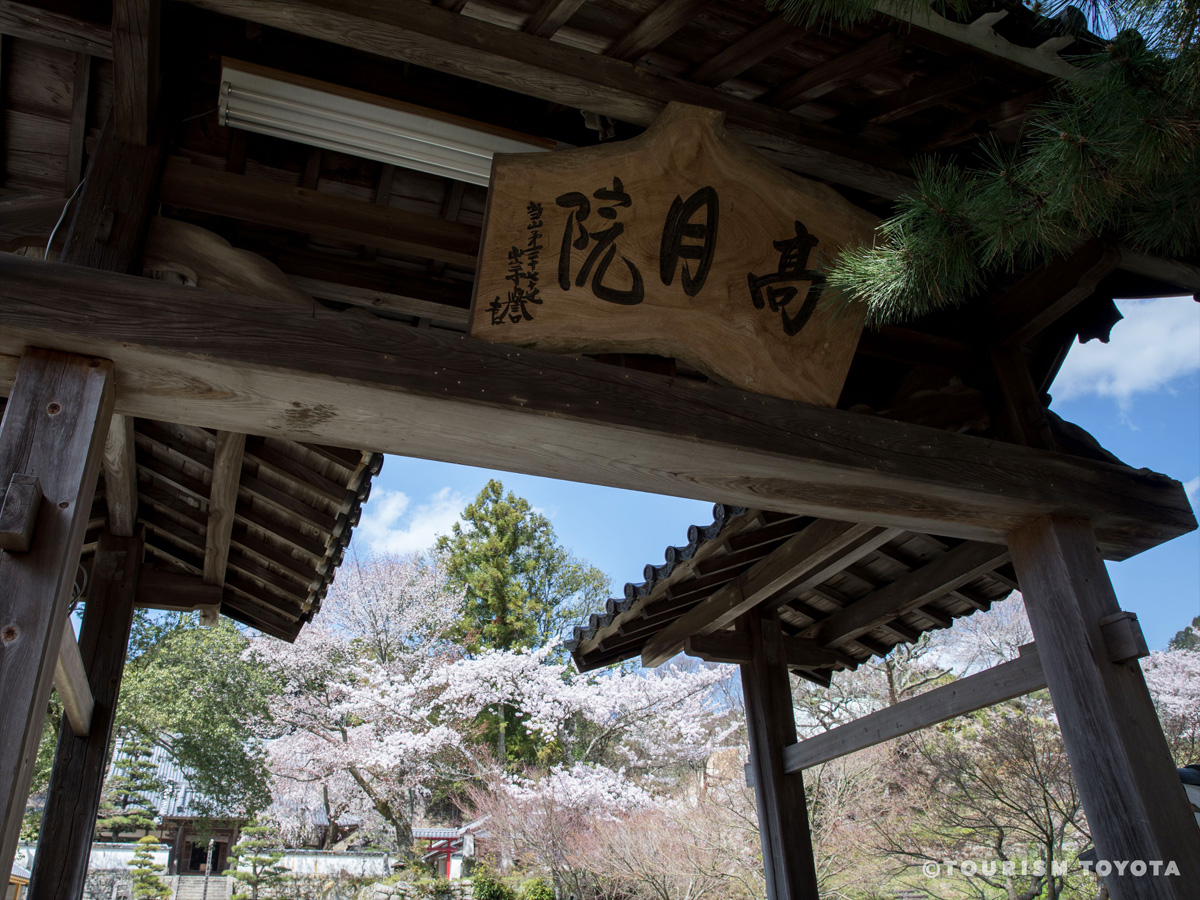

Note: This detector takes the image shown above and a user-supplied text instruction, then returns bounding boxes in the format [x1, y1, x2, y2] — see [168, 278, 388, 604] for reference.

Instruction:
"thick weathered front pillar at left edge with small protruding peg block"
[0, 349, 113, 872]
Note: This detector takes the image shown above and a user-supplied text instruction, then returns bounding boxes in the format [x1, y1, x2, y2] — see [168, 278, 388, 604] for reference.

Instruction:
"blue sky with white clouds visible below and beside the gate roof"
[354, 298, 1200, 648]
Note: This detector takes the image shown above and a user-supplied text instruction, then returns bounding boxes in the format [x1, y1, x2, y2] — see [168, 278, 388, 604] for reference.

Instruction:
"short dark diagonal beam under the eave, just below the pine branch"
[991, 240, 1121, 347]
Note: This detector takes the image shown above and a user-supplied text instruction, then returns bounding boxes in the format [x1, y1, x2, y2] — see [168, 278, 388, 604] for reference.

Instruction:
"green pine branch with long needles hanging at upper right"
[778, 0, 1200, 324]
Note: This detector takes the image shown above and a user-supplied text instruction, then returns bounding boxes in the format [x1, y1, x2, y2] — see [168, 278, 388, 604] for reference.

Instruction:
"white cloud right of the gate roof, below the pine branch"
[1050, 298, 1200, 409]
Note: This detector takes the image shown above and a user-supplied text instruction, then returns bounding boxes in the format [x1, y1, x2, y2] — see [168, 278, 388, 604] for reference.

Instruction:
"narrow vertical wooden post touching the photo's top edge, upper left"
[113, 0, 161, 146]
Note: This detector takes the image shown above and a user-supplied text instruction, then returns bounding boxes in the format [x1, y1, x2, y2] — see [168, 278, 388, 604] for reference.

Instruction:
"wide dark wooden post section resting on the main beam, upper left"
[62, 115, 162, 275]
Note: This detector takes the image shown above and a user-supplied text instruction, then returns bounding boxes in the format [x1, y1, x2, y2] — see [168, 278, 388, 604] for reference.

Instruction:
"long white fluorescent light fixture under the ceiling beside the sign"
[218, 59, 554, 186]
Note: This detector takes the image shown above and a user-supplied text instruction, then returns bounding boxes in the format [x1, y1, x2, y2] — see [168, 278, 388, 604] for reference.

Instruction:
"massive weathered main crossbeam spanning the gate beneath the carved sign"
[0, 257, 1195, 558]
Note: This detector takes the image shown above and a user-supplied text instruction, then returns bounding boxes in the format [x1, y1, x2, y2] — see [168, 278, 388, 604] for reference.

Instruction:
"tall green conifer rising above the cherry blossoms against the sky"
[437, 479, 608, 653]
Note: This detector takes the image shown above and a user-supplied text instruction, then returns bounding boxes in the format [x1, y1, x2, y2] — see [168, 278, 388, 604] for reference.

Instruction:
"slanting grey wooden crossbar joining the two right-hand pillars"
[784, 647, 1046, 772]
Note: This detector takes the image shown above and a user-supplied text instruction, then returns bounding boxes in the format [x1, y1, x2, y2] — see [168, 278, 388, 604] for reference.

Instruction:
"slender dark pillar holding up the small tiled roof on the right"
[740, 610, 817, 900]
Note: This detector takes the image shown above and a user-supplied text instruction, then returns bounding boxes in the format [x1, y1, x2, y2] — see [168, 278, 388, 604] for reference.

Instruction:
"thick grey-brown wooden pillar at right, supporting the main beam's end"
[1008, 516, 1200, 900]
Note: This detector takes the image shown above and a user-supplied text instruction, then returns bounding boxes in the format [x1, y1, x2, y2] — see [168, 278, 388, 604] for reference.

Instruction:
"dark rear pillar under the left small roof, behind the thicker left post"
[29, 533, 143, 900]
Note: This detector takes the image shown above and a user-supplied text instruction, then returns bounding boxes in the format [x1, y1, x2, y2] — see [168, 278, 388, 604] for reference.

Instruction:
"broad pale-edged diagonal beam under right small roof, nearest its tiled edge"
[642, 520, 899, 667]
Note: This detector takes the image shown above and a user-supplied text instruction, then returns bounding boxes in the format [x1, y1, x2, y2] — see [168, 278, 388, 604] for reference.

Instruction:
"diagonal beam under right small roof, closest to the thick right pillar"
[810, 541, 1008, 647]
